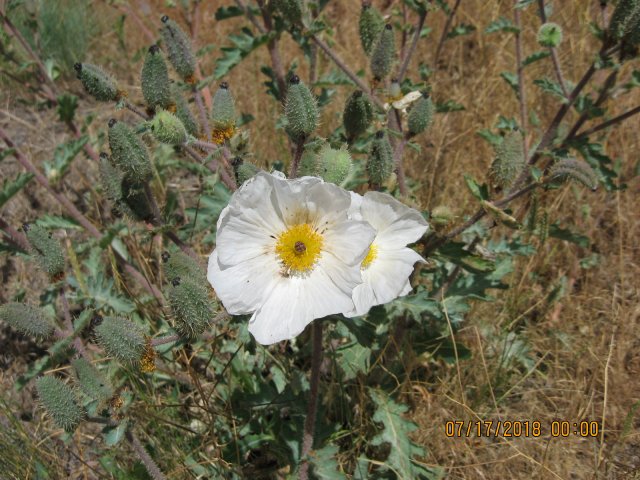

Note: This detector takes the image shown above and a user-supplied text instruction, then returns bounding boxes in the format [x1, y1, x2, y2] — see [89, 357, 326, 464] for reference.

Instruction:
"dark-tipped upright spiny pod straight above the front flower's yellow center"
[284, 75, 319, 138]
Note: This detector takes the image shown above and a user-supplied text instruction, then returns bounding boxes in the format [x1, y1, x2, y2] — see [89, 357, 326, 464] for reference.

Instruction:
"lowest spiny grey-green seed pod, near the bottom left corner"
[36, 376, 84, 433]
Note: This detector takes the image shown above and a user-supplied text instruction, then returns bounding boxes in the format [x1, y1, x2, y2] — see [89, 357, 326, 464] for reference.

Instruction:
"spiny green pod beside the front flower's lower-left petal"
[168, 277, 215, 339]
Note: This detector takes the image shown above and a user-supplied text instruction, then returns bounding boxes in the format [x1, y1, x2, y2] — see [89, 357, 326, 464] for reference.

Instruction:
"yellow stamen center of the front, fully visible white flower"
[276, 223, 322, 273]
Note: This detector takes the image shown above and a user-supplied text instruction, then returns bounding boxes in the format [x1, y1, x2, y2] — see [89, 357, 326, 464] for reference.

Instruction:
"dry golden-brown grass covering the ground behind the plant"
[0, 0, 640, 480]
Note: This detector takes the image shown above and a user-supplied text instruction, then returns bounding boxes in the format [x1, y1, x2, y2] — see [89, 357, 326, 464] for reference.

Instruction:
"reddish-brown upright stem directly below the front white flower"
[299, 319, 322, 480]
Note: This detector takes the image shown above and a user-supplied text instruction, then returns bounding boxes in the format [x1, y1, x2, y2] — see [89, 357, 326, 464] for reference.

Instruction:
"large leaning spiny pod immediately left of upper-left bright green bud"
[109, 119, 152, 182]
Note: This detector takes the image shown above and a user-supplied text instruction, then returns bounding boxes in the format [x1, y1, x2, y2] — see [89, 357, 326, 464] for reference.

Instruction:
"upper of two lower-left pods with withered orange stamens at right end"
[95, 317, 146, 364]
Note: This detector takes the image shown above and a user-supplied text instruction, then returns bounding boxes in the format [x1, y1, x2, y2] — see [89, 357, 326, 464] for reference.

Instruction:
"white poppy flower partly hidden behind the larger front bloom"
[345, 192, 429, 317]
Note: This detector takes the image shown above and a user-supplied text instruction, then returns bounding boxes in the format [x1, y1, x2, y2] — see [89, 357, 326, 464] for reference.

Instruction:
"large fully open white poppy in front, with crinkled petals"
[207, 172, 375, 345]
